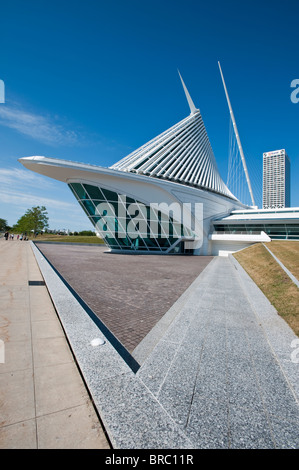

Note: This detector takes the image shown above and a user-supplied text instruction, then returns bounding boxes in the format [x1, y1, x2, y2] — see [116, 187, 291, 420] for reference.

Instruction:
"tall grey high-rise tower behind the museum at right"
[263, 149, 290, 209]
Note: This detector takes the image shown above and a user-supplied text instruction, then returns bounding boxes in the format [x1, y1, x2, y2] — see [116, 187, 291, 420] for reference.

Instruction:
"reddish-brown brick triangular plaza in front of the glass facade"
[37, 243, 212, 352]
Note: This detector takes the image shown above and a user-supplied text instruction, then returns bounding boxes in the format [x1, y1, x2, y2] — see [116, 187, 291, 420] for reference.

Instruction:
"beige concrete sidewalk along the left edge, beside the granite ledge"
[0, 239, 109, 449]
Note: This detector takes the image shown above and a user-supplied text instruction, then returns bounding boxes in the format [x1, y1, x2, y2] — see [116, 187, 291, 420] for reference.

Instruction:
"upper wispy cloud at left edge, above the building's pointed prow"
[0, 104, 79, 145]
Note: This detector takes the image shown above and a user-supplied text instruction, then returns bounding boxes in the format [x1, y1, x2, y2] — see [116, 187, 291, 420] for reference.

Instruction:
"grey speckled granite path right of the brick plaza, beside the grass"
[137, 258, 299, 449]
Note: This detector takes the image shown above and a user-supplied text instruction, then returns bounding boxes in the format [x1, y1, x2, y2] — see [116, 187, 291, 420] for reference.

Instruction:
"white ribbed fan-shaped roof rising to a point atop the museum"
[110, 101, 236, 199]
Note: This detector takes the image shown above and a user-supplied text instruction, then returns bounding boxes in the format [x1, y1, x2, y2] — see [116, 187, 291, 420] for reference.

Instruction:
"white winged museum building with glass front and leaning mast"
[19, 69, 299, 255]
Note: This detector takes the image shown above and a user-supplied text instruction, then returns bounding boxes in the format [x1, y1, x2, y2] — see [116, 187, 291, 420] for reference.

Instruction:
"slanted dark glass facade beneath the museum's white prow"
[69, 183, 194, 253]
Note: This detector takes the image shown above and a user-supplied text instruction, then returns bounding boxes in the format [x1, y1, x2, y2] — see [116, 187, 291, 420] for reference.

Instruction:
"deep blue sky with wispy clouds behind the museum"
[0, 0, 299, 230]
